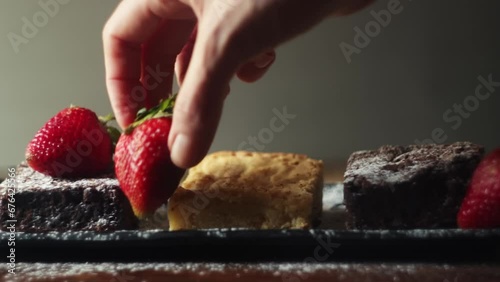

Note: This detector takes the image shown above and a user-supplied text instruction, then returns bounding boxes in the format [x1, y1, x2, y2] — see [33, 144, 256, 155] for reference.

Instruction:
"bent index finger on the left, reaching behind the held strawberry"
[103, 0, 160, 128]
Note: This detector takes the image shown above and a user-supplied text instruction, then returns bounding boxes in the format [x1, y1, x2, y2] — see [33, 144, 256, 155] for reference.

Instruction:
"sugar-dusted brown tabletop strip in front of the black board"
[0, 263, 500, 282]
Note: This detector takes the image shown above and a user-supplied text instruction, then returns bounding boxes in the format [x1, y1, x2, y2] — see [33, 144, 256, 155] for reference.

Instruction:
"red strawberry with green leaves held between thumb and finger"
[114, 97, 184, 218]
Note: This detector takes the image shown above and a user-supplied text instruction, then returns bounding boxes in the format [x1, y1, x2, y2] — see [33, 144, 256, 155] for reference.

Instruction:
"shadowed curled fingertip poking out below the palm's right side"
[236, 50, 276, 82]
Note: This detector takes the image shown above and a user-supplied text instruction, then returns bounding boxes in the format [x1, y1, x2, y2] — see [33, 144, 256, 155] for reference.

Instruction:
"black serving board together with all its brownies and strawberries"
[0, 103, 500, 263]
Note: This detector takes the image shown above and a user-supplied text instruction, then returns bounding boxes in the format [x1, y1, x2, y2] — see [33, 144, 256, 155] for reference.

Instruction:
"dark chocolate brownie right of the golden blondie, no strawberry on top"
[344, 142, 484, 229]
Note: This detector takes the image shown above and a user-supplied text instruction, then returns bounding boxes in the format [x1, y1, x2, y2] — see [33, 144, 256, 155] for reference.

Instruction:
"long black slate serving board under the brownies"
[0, 184, 500, 263]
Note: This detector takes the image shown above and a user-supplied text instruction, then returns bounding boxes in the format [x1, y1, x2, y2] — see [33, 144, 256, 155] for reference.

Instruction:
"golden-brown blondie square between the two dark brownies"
[168, 151, 323, 230]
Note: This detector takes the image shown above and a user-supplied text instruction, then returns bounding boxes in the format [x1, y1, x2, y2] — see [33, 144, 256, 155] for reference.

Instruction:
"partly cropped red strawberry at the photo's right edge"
[457, 148, 500, 228]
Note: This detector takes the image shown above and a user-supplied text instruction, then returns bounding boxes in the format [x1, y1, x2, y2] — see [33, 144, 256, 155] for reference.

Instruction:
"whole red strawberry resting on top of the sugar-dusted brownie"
[26, 107, 117, 177]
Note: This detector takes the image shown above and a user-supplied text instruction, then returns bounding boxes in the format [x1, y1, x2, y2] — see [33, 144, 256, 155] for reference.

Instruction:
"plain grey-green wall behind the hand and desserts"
[0, 0, 500, 175]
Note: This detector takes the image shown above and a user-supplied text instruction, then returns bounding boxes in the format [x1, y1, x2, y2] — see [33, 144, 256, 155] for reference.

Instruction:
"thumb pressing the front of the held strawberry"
[169, 24, 238, 168]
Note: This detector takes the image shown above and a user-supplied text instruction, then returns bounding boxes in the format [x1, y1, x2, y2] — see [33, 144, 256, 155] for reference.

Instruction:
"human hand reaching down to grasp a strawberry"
[103, 0, 372, 168]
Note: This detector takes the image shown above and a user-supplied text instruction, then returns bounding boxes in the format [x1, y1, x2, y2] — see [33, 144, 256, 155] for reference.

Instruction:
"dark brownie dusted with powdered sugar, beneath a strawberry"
[0, 164, 138, 232]
